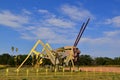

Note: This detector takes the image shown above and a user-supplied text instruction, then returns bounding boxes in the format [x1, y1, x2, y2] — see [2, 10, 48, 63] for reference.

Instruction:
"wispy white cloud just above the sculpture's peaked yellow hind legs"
[21, 26, 73, 44]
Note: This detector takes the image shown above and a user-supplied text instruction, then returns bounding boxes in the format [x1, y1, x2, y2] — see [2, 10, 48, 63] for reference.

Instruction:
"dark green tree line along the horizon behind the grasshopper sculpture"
[0, 53, 120, 66]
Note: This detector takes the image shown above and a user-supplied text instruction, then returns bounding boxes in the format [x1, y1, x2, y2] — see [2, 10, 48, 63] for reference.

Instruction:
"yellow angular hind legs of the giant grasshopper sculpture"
[17, 40, 59, 70]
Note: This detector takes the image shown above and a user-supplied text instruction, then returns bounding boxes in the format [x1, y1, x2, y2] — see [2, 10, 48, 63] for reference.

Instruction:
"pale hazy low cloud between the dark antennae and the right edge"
[81, 30, 120, 46]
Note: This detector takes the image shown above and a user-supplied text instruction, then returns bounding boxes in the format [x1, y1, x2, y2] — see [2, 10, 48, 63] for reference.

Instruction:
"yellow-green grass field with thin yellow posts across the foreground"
[0, 67, 120, 80]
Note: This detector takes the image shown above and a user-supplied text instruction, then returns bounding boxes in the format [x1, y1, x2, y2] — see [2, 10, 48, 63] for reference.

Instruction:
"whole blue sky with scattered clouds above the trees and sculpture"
[0, 0, 120, 58]
